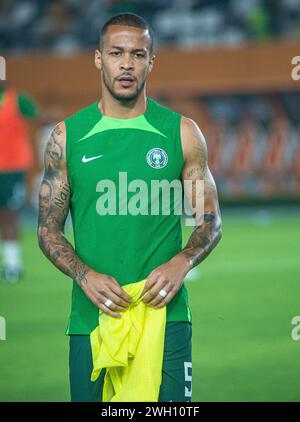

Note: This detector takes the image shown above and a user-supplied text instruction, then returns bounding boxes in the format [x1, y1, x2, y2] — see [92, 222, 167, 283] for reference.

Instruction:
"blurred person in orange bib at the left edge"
[0, 81, 38, 282]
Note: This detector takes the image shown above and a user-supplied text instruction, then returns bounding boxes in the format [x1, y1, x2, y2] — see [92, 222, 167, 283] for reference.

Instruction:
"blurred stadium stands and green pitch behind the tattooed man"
[0, 0, 300, 401]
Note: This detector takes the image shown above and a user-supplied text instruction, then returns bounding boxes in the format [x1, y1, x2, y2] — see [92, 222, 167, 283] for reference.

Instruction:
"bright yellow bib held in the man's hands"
[90, 280, 166, 402]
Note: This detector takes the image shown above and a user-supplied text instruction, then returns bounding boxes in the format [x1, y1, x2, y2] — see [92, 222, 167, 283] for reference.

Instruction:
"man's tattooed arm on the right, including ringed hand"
[142, 117, 221, 308]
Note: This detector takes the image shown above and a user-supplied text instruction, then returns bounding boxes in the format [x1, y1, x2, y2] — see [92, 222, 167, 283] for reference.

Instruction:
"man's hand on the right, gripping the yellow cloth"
[141, 254, 190, 308]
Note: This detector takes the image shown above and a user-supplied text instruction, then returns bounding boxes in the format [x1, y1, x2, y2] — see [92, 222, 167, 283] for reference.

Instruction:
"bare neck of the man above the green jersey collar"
[98, 94, 148, 119]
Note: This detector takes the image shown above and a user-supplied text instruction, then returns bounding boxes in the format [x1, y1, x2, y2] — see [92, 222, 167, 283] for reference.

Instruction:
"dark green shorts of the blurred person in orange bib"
[0, 171, 26, 211]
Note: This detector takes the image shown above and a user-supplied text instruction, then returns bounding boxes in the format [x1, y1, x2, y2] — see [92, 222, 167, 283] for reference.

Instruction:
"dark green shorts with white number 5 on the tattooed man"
[69, 322, 192, 402]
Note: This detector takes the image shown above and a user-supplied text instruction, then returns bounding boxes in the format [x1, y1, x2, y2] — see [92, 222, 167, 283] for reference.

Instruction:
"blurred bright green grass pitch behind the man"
[0, 216, 300, 401]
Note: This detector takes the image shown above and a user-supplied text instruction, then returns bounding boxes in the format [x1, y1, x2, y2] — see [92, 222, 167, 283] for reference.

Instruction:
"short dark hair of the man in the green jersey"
[99, 13, 154, 54]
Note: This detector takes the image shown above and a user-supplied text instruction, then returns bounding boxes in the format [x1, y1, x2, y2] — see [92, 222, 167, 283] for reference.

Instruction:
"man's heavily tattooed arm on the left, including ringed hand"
[38, 123, 131, 317]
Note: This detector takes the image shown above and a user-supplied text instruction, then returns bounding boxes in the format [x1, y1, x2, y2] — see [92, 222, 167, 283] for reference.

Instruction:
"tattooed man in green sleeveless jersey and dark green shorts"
[38, 13, 221, 402]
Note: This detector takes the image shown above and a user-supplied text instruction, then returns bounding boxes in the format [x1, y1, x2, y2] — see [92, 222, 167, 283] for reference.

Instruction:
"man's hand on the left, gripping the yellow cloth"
[80, 270, 132, 318]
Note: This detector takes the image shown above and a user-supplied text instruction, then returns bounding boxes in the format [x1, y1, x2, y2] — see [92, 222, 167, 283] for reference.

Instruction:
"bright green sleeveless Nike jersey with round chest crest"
[65, 98, 191, 334]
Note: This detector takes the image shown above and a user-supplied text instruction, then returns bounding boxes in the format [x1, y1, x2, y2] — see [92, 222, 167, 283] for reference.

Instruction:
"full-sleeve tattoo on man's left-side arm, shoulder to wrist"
[38, 126, 90, 287]
